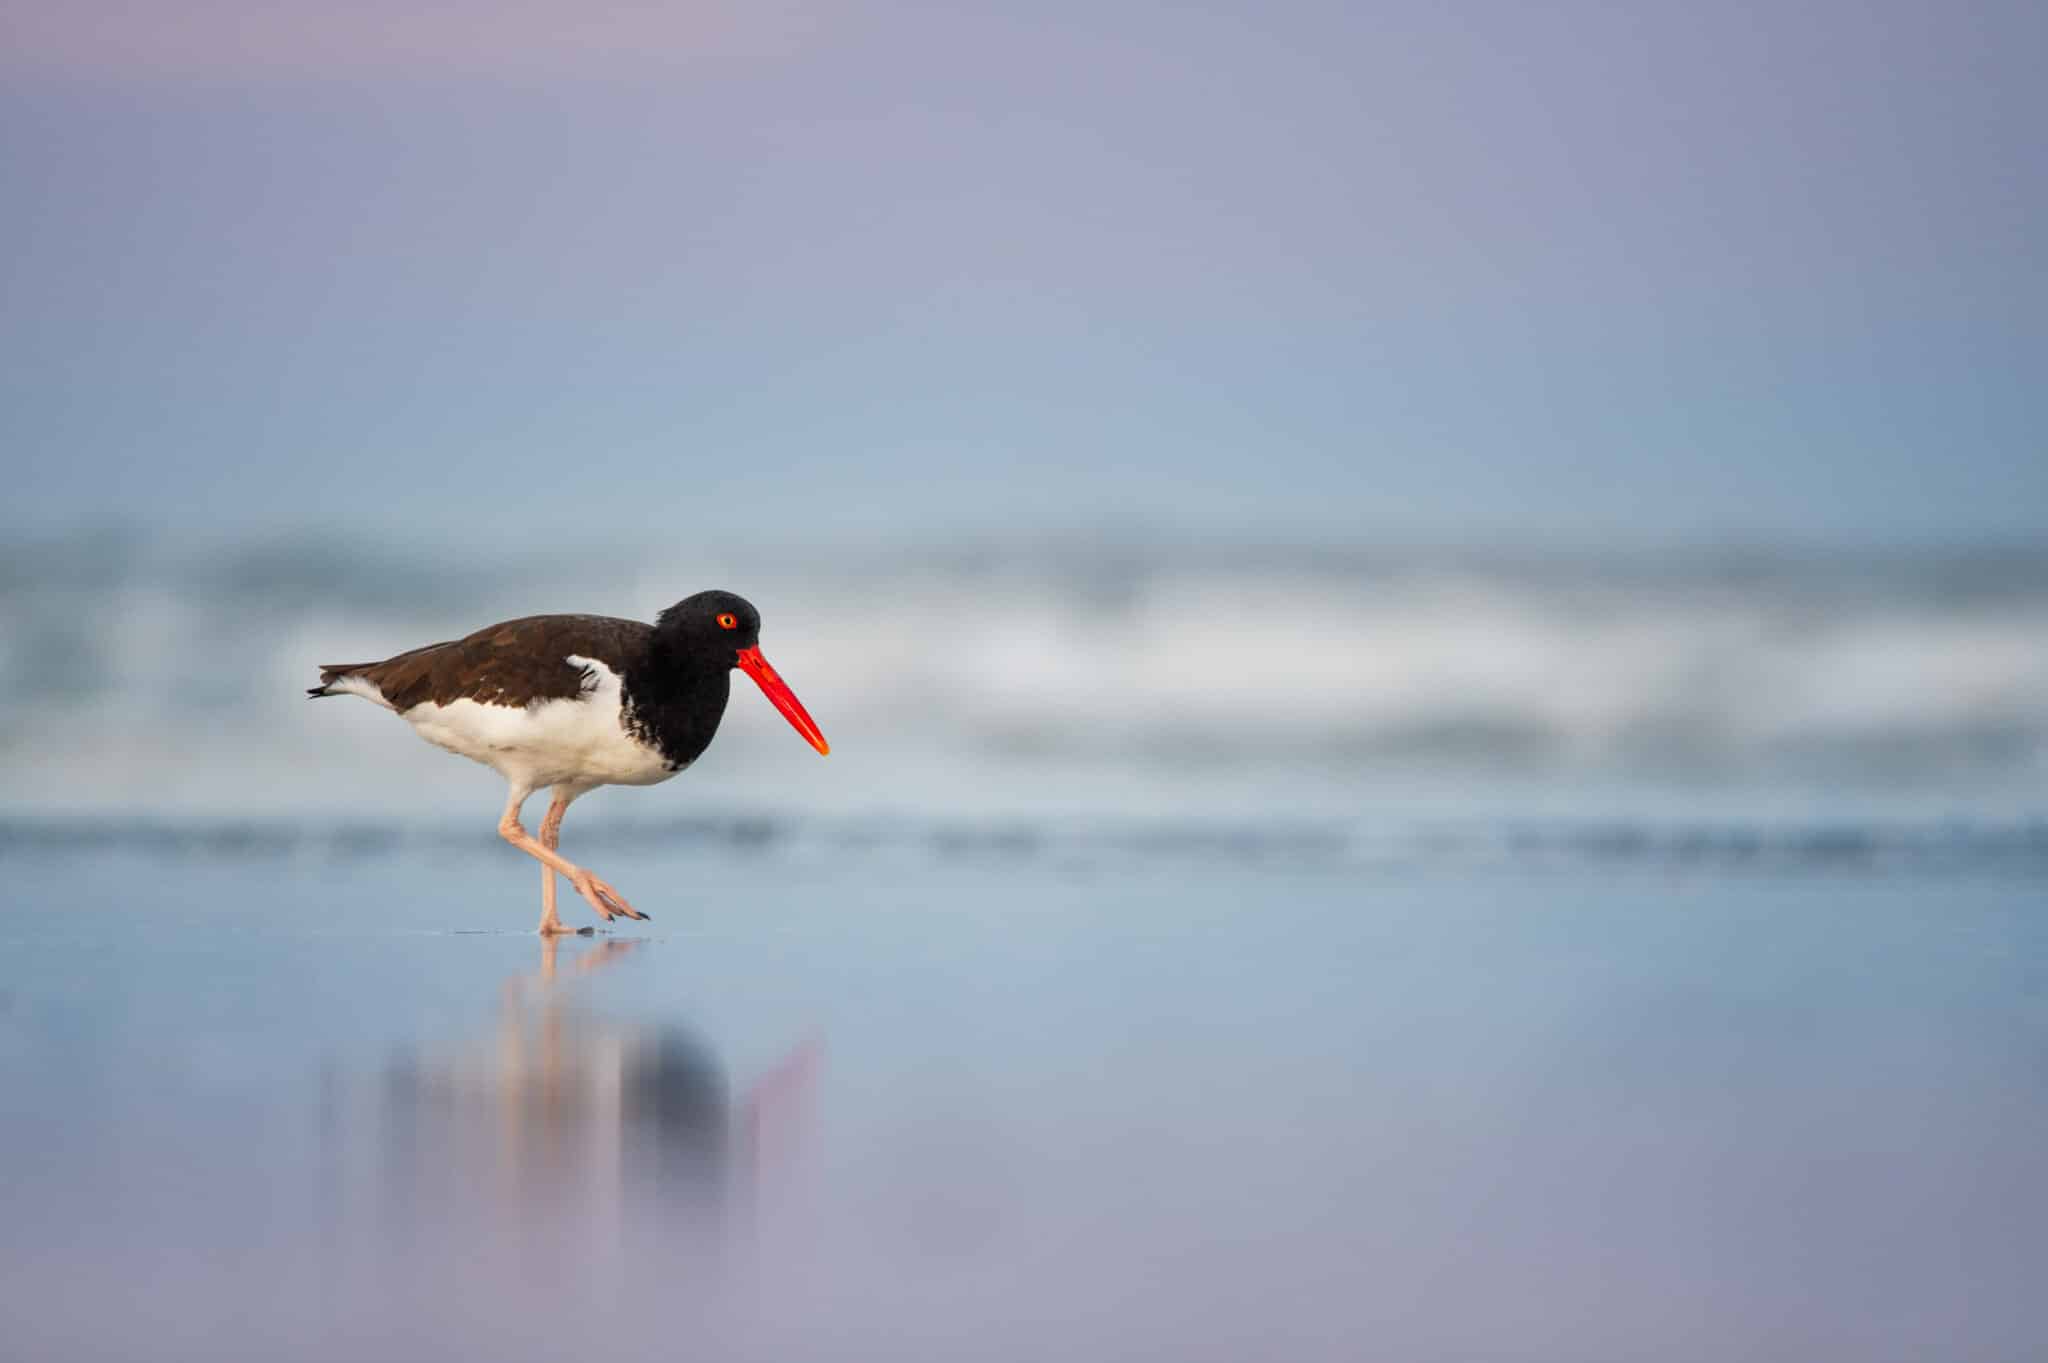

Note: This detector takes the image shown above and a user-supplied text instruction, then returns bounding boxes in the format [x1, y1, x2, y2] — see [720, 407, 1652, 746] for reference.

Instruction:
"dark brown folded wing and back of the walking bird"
[319, 616, 653, 714]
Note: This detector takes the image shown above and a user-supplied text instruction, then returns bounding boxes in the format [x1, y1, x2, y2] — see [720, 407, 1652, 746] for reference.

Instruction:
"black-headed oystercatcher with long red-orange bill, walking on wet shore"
[307, 591, 831, 935]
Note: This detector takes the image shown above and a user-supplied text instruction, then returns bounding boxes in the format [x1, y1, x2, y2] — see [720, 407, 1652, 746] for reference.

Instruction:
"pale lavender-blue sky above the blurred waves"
[0, 0, 2048, 542]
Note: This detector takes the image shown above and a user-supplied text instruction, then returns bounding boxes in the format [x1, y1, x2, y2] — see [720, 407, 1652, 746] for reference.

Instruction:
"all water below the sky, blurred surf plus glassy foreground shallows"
[0, 534, 2048, 1363]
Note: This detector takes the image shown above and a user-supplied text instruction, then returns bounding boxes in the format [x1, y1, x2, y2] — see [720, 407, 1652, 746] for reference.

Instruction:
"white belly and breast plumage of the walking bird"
[406, 653, 680, 790]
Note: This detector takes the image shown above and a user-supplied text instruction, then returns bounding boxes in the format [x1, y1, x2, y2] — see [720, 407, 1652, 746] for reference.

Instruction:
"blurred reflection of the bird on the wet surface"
[328, 937, 819, 1273]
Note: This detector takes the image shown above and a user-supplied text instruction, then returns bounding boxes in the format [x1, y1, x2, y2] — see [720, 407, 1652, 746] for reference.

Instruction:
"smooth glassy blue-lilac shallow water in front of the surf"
[0, 829, 2048, 1361]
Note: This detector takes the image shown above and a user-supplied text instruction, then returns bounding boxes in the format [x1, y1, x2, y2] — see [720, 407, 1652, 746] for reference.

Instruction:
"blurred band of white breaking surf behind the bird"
[0, 544, 2048, 810]
